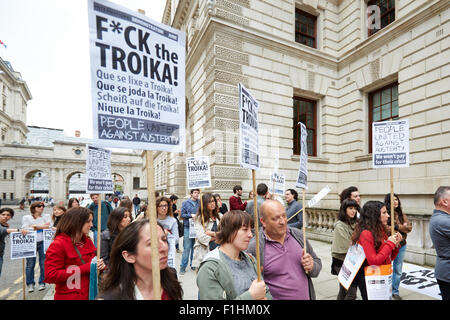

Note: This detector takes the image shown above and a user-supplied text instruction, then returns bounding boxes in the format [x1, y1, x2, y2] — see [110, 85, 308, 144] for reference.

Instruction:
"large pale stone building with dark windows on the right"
[155, 0, 450, 264]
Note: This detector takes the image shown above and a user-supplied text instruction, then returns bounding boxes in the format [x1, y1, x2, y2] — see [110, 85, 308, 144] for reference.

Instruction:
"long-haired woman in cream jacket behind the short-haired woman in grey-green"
[192, 193, 222, 268]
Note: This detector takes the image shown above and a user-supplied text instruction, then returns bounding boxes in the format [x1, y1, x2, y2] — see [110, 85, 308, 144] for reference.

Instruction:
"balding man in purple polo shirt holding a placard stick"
[247, 200, 322, 300]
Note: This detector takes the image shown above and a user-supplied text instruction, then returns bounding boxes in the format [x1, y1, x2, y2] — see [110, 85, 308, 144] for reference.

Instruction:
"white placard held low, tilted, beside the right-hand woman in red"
[338, 244, 366, 290]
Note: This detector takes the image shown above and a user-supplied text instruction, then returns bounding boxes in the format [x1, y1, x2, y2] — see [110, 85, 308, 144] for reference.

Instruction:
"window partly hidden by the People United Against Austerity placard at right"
[369, 82, 399, 153]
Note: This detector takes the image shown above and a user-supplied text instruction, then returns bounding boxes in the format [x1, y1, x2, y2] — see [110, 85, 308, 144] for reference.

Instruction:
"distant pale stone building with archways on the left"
[0, 58, 142, 205]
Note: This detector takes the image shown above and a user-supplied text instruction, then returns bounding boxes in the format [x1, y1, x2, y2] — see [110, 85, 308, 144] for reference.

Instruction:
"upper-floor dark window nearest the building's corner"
[295, 9, 317, 48]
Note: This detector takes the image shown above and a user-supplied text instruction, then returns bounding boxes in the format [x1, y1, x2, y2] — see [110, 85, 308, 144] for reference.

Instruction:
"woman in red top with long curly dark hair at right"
[352, 201, 402, 300]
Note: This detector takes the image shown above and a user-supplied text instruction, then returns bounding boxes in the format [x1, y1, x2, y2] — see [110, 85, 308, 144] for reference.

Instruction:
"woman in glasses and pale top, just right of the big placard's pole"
[156, 197, 180, 268]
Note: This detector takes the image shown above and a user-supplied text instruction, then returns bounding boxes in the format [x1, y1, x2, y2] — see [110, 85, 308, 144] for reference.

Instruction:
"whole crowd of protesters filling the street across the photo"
[0, 183, 450, 300]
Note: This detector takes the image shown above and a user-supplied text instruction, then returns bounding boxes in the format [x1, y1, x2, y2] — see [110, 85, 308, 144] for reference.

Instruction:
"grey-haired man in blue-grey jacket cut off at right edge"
[429, 186, 450, 300]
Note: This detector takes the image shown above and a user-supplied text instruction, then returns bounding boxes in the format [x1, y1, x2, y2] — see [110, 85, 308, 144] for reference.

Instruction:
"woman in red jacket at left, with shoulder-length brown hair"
[44, 207, 105, 300]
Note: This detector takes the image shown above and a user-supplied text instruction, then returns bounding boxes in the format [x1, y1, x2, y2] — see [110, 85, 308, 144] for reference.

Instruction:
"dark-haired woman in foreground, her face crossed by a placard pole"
[99, 218, 183, 300]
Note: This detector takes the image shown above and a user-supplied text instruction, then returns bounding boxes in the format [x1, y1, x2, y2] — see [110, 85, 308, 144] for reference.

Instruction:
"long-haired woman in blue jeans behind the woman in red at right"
[384, 193, 412, 300]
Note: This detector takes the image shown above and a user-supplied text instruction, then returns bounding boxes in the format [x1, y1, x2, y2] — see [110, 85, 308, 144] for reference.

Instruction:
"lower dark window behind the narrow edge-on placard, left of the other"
[293, 97, 317, 157]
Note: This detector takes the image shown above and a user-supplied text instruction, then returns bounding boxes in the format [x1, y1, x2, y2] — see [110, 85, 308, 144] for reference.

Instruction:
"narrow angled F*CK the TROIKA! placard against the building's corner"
[238, 83, 260, 170]
